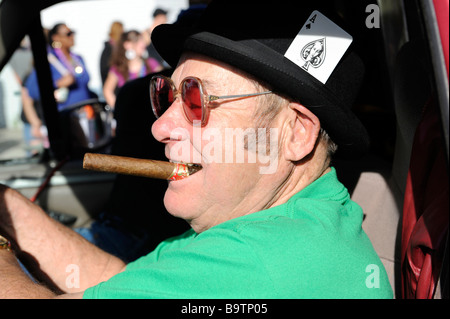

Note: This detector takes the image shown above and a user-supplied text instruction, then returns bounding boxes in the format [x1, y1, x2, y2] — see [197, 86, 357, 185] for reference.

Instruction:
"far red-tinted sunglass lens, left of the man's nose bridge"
[150, 77, 174, 117]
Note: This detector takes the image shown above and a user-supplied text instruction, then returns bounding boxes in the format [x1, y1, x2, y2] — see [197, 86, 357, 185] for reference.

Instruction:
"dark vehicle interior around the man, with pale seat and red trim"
[0, 0, 449, 299]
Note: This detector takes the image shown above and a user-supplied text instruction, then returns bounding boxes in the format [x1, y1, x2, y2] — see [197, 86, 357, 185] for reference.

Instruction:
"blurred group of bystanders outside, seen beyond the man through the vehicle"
[10, 8, 174, 156]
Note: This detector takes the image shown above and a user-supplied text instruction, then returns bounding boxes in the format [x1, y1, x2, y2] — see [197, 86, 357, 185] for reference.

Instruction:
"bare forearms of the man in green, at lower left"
[0, 185, 125, 298]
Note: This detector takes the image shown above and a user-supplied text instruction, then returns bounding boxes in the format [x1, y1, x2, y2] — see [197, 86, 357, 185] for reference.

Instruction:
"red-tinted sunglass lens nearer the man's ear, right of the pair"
[181, 79, 203, 123]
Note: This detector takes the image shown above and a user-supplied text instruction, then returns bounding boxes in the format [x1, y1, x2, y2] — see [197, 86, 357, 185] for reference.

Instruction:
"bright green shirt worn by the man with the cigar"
[83, 169, 393, 299]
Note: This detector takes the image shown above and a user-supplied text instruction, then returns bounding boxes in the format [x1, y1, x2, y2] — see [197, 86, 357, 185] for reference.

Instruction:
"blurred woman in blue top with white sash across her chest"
[25, 23, 95, 111]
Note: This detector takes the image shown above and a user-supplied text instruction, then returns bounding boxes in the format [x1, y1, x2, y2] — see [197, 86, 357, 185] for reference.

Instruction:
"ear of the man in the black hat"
[283, 102, 320, 162]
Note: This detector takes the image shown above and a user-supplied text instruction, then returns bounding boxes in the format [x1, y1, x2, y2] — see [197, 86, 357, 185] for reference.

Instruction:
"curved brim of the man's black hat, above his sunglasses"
[152, 25, 369, 157]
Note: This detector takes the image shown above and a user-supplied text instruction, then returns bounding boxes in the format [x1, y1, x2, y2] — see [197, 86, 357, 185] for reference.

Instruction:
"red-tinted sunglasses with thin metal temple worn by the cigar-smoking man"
[150, 75, 272, 126]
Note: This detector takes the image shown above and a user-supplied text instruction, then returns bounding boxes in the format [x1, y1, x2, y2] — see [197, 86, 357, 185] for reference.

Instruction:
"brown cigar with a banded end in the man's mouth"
[83, 153, 201, 181]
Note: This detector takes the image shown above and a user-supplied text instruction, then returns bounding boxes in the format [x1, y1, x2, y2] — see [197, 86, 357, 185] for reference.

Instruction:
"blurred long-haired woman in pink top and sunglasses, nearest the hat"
[103, 30, 162, 107]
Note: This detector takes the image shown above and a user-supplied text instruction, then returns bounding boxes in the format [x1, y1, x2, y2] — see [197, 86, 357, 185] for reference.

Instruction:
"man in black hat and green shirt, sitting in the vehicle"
[0, 1, 392, 298]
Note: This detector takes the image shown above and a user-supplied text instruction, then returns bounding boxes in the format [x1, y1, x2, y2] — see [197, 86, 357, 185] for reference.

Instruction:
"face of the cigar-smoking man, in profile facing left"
[152, 54, 284, 232]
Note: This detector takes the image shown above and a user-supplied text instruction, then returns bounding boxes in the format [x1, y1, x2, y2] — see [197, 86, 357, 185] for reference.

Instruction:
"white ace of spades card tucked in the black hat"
[285, 10, 353, 84]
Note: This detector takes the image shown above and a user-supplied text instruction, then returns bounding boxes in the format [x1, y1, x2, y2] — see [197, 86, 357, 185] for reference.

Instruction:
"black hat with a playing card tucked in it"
[152, 0, 369, 156]
